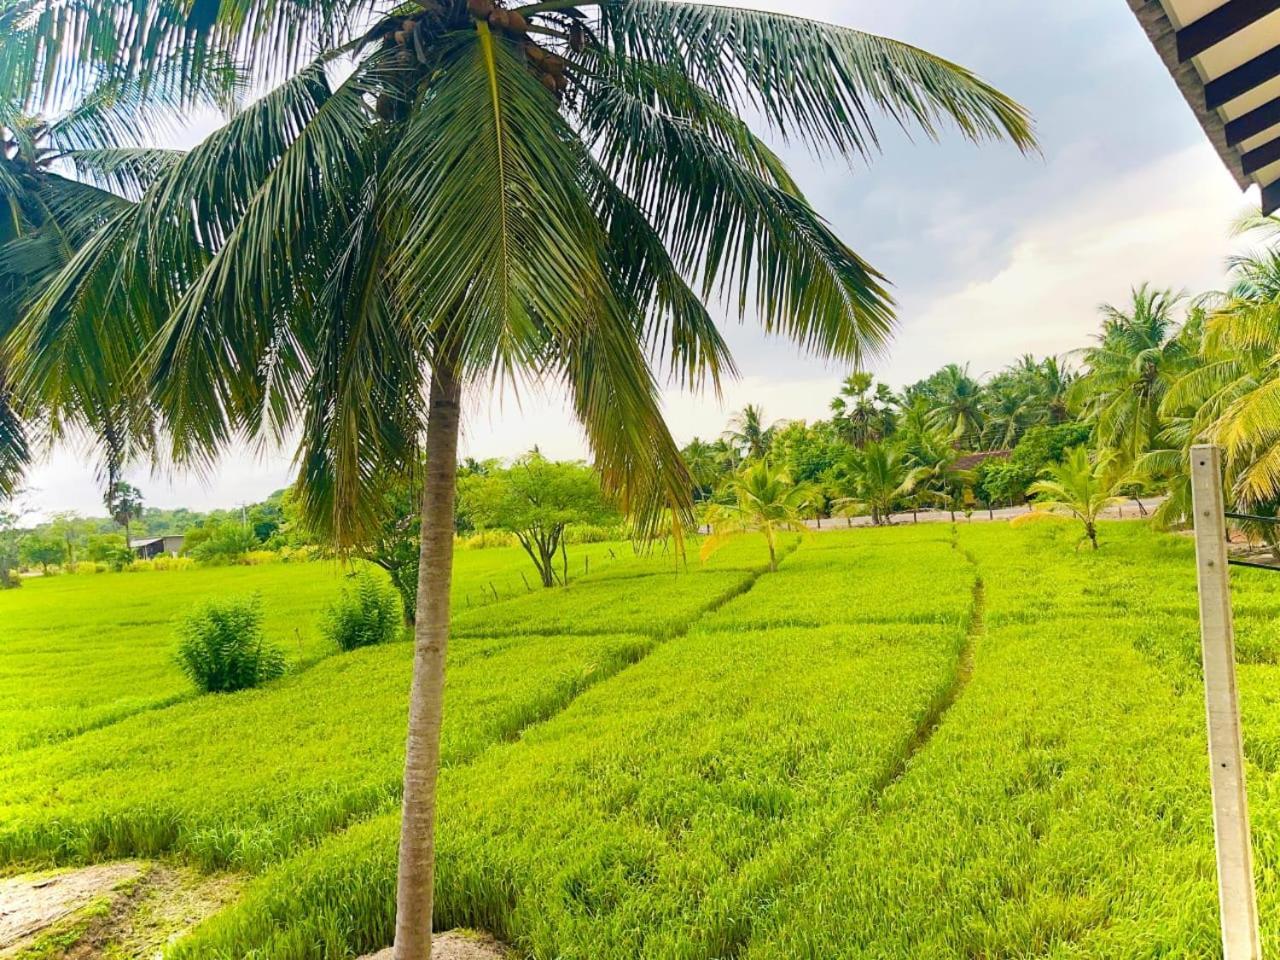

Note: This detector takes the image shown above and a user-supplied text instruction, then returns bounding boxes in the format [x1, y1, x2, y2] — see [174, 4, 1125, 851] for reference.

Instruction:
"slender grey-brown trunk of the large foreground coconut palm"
[396, 367, 462, 960]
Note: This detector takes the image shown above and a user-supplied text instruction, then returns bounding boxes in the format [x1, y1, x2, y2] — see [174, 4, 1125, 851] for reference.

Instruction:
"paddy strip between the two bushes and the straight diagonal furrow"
[0, 537, 759, 868]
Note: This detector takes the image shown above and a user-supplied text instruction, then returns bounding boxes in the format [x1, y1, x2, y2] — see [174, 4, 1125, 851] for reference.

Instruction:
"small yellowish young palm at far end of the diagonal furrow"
[701, 460, 812, 572]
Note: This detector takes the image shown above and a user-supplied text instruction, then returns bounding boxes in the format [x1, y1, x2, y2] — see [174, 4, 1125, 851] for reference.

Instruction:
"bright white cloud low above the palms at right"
[883, 146, 1245, 383]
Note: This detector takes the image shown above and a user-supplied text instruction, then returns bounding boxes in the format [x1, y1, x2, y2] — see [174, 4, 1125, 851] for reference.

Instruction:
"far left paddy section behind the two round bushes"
[0, 544, 624, 755]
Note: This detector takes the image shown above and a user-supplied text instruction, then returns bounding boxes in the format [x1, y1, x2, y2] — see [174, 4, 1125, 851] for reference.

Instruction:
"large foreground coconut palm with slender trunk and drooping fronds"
[10, 0, 1033, 960]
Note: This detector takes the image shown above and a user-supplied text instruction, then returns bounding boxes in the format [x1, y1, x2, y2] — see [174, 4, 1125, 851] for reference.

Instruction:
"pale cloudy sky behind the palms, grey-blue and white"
[27, 0, 1245, 513]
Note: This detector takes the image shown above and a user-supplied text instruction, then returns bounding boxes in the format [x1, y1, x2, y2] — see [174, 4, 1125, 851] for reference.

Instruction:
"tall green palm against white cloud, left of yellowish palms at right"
[1071, 284, 1194, 463]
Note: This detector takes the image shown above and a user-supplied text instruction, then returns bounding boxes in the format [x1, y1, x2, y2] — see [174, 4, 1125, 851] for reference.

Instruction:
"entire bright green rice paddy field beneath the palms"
[0, 524, 1280, 960]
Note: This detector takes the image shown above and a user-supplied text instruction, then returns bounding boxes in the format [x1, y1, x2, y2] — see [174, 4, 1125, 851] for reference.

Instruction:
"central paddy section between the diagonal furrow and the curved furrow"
[165, 534, 973, 960]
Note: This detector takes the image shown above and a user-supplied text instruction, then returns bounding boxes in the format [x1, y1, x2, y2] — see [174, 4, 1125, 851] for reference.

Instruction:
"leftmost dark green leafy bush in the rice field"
[178, 598, 284, 694]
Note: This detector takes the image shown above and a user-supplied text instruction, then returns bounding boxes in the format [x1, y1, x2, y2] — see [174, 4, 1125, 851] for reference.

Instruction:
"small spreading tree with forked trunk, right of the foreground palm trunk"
[460, 453, 618, 586]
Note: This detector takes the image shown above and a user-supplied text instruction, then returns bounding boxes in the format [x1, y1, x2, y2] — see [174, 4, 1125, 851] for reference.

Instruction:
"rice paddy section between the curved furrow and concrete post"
[746, 527, 1216, 960]
